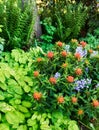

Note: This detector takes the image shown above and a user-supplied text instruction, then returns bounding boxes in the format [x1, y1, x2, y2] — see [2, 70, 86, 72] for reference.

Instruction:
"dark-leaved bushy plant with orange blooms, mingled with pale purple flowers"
[31, 39, 99, 124]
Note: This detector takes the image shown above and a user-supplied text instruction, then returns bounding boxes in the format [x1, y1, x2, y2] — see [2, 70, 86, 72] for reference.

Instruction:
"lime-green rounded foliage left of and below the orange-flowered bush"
[0, 47, 78, 130]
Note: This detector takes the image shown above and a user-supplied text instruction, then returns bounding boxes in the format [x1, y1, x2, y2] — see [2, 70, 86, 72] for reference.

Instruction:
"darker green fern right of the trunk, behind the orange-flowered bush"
[55, 3, 87, 41]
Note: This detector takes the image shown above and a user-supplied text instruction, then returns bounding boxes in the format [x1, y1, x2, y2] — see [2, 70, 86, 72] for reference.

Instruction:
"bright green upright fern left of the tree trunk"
[0, 0, 35, 50]
